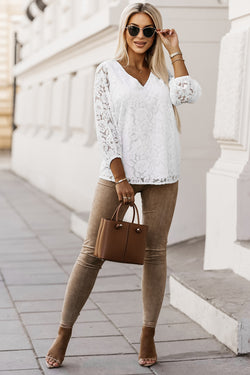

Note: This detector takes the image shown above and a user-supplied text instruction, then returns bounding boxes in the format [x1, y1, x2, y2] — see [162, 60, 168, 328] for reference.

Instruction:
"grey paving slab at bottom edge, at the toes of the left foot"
[39, 354, 150, 375]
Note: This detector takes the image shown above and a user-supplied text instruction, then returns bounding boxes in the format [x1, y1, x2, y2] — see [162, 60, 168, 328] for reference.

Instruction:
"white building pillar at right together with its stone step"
[170, 0, 250, 354]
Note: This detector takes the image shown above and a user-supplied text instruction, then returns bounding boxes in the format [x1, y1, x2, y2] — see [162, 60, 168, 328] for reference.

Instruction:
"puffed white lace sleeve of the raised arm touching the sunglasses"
[168, 71, 202, 106]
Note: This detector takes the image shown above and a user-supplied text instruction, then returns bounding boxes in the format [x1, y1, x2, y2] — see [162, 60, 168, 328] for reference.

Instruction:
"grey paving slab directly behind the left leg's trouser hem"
[20, 309, 107, 325]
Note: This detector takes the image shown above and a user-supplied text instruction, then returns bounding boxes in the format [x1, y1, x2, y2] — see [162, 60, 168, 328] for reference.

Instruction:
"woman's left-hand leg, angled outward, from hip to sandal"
[47, 179, 128, 367]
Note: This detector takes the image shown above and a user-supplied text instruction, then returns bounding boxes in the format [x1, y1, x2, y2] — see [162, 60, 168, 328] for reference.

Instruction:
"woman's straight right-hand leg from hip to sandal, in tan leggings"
[139, 181, 178, 365]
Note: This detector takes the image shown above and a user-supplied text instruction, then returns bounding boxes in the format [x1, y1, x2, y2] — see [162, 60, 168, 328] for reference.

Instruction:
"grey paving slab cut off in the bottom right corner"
[154, 356, 250, 375]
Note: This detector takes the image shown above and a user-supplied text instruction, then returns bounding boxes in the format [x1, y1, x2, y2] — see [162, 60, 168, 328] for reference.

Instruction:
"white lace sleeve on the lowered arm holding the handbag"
[94, 63, 121, 167]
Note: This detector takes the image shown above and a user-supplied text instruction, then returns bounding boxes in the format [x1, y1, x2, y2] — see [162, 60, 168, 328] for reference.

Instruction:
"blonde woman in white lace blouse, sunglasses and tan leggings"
[46, 3, 201, 368]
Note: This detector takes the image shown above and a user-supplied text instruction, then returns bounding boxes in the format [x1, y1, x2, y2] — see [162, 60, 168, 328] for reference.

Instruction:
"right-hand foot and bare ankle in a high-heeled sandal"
[138, 326, 157, 367]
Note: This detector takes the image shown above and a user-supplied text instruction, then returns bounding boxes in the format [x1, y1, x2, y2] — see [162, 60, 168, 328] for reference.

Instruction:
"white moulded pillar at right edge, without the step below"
[204, 0, 250, 280]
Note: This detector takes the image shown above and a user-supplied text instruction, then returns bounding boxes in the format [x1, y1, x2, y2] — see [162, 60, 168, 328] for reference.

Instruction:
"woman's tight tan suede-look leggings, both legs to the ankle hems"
[60, 178, 178, 328]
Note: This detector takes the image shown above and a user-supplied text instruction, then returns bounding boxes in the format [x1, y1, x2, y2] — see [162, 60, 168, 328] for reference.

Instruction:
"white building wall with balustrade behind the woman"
[12, 0, 229, 244]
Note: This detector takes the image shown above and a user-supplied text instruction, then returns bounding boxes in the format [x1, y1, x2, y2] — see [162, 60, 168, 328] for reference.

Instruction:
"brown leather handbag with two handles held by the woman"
[94, 203, 148, 264]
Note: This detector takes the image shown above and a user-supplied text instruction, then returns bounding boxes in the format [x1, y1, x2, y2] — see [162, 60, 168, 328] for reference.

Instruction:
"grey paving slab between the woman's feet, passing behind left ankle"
[32, 336, 135, 357]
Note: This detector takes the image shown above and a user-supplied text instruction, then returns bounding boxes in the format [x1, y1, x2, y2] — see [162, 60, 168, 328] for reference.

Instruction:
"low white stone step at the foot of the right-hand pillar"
[170, 269, 250, 354]
